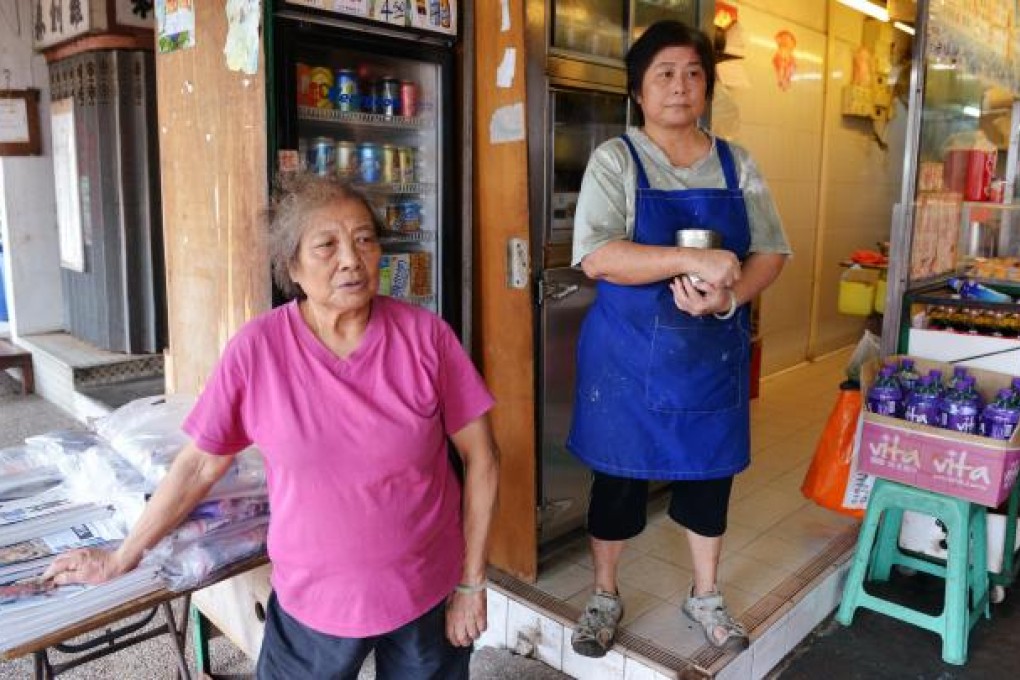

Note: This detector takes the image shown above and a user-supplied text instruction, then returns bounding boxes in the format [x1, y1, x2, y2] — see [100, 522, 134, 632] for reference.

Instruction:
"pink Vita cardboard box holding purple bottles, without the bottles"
[858, 357, 1020, 508]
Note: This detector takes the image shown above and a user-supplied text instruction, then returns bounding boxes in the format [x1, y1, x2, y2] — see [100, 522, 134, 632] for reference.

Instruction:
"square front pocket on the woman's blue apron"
[645, 319, 747, 413]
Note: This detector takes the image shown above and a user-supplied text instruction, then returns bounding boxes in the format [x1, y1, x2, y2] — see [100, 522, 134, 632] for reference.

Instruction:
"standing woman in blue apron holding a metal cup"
[567, 21, 791, 657]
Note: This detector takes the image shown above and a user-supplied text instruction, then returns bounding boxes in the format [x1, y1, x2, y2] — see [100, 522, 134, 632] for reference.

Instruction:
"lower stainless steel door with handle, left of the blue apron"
[539, 267, 595, 543]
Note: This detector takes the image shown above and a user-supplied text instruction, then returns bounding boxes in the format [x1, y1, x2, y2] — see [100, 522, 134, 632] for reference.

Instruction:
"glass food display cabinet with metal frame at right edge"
[882, 0, 1020, 374]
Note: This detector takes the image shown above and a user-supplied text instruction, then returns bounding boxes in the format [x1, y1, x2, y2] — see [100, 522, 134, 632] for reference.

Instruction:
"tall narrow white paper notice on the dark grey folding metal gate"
[50, 97, 85, 271]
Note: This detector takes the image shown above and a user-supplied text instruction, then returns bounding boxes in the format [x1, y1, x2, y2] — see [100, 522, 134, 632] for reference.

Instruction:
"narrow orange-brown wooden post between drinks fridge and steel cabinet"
[473, 0, 538, 581]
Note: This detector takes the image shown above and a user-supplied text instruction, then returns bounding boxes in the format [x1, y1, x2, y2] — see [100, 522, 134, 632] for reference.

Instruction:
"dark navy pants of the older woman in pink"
[256, 593, 471, 680]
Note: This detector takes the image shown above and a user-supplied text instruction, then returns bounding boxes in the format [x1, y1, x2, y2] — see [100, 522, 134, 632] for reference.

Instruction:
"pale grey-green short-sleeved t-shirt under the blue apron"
[572, 127, 793, 266]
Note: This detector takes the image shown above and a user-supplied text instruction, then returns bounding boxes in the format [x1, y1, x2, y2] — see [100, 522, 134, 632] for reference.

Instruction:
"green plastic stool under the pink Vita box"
[835, 479, 990, 665]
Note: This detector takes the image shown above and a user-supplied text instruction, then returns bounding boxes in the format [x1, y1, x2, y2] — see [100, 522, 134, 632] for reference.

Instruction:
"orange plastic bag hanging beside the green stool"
[801, 388, 864, 518]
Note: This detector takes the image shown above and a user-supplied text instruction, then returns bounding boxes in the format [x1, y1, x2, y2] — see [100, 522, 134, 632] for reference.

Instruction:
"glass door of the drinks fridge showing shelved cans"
[295, 47, 444, 313]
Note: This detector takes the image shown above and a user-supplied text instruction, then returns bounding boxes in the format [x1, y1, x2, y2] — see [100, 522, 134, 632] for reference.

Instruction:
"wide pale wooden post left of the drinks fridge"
[156, 2, 270, 394]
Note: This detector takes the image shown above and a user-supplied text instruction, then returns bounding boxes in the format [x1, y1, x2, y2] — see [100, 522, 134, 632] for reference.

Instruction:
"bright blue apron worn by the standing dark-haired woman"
[567, 136, 751, 480]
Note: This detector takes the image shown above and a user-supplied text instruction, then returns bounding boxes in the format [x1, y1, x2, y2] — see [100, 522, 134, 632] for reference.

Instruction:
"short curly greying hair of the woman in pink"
[266, 172, 383, 300]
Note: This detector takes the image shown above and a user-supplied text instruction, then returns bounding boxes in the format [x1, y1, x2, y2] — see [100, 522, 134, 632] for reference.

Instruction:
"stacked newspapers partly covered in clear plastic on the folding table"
[0, 397, 269, 650]
